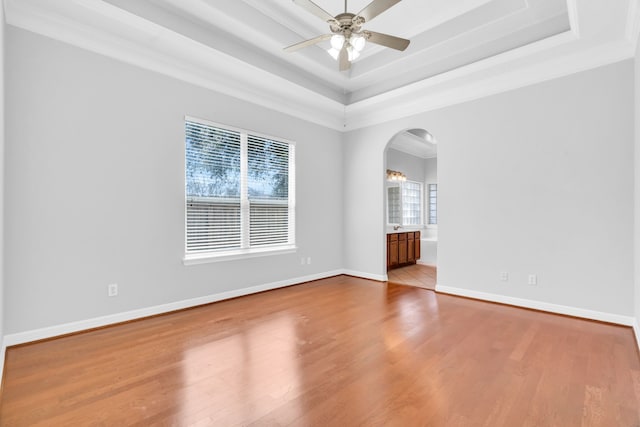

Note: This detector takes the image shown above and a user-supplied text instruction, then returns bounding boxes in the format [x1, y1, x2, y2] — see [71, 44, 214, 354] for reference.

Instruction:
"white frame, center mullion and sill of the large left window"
[182, 116, 297, 265]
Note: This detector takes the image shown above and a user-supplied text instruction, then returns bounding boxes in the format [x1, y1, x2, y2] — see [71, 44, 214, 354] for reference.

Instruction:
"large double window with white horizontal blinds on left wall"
[185, 118, 295, 259]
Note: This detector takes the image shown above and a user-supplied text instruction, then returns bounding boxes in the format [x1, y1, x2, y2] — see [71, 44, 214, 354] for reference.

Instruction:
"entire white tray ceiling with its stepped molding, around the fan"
[5, 0, 640, 130]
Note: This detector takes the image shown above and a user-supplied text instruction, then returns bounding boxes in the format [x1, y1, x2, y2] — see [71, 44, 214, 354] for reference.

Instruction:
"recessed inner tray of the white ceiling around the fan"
[105, 0, 570, 104]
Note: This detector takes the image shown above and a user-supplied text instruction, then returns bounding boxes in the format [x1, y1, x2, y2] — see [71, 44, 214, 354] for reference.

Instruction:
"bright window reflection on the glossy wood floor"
[181, 315, 302, 425]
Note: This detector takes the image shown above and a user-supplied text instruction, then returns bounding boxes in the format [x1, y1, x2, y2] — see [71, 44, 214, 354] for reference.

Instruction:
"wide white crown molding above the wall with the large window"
[5, 0, 344, 130]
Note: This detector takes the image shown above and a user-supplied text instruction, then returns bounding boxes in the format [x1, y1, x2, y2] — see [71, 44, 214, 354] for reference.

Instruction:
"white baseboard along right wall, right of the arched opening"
[436, 285, 638, 326]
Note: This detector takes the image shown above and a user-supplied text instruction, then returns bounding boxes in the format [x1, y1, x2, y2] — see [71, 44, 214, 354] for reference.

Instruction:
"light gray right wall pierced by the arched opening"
[344, 60, 634, 316]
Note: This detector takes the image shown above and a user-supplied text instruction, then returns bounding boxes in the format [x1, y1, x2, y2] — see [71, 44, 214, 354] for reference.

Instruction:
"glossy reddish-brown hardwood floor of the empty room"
[0, 276, 640, 427]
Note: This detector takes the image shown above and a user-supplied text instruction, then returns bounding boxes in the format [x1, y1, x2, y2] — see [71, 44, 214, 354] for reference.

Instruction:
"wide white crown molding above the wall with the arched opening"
[345, 33, 635, 131]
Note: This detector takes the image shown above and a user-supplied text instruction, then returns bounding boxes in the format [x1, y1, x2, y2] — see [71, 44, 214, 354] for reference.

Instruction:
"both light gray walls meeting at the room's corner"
[0, 23, 640, 334]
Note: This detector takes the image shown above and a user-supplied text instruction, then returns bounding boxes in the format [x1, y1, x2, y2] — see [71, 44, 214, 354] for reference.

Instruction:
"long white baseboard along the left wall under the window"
[2, 270, 350, 348]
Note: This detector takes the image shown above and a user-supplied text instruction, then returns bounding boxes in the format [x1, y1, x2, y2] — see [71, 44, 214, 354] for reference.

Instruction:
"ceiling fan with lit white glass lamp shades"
[284, 0, 410, 71]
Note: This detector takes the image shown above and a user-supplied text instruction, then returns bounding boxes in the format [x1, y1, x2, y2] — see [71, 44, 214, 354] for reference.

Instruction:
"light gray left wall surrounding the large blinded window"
[5, 26, 343, 334]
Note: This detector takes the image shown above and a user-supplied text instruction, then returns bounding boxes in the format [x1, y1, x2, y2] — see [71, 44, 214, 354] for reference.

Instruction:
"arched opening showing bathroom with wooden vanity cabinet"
[384, 128, 438, 289]
